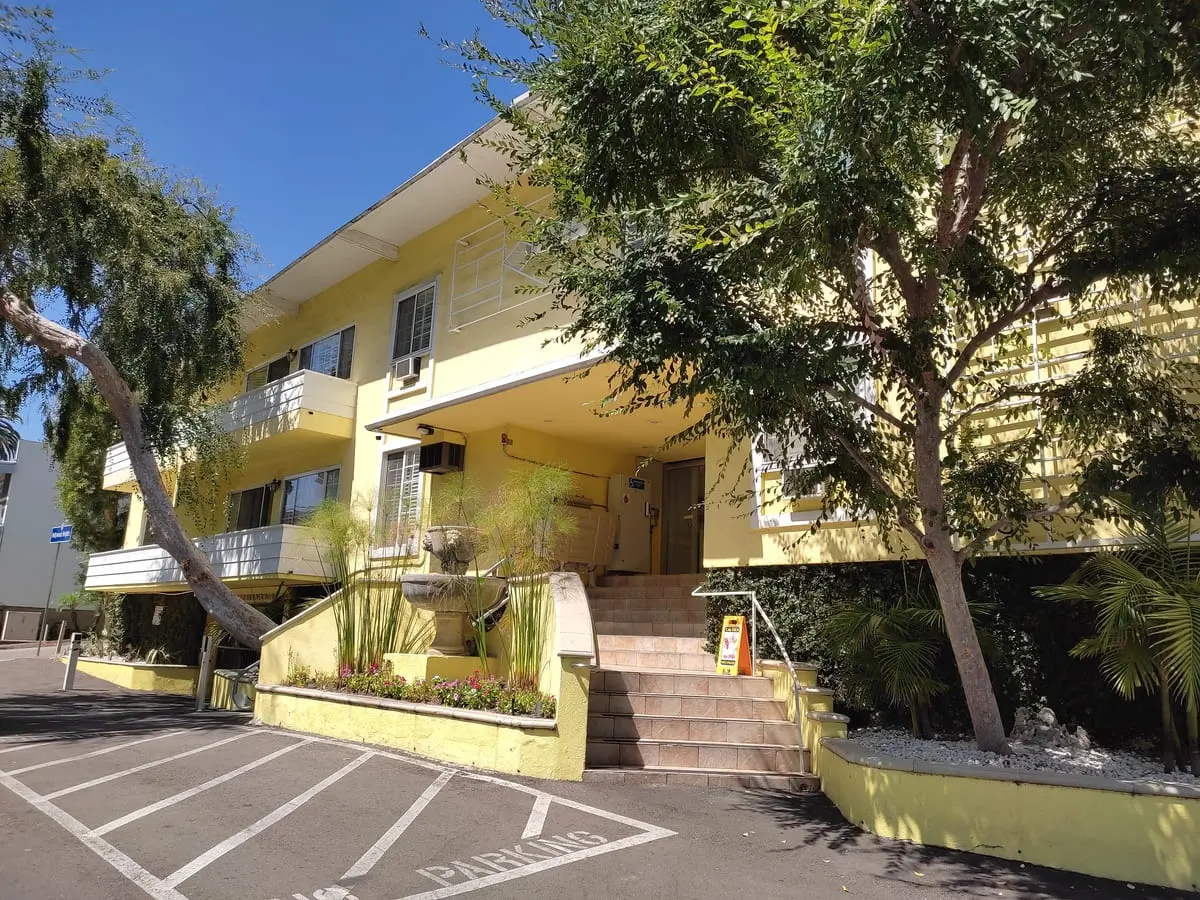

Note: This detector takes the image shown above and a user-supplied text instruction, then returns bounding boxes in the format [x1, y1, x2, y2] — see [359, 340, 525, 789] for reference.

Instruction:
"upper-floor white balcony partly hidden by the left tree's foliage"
[103, 370, 359, 492]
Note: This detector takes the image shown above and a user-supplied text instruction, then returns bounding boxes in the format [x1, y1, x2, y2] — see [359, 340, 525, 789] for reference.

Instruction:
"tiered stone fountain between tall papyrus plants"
[400, 526, 508, 656]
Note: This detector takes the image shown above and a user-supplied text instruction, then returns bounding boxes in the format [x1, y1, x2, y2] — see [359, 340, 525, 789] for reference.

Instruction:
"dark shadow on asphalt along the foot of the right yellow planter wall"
[731, 791, 1195, 900]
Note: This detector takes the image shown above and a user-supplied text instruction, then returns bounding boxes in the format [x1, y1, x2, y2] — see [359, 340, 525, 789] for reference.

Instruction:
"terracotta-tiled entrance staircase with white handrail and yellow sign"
[583, 575, 820, 791]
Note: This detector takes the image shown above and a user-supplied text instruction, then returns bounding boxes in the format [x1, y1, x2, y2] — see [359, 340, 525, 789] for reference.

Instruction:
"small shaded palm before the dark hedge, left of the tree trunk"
[822, 584, 992, 738]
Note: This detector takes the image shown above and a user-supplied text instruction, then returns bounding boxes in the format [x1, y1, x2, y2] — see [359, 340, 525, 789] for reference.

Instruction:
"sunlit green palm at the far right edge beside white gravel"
[1038, 504, 1200, 774]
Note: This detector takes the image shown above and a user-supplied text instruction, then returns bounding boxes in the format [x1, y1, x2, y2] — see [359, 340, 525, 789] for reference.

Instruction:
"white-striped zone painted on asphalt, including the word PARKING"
[0, 720, 673, 900]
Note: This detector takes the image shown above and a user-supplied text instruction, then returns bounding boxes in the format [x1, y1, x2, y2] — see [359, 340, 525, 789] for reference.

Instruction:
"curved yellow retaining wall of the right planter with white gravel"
[817, 738, 1200, 892]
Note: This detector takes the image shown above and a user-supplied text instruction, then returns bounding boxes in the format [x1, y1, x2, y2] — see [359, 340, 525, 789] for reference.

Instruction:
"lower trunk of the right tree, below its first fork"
[925, 547, 1012, 754]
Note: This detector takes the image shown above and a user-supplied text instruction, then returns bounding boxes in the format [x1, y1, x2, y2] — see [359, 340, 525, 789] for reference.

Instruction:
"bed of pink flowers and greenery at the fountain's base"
[286, 665, 557, 719]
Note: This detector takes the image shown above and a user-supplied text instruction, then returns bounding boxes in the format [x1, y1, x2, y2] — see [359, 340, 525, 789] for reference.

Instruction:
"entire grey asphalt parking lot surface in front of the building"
[0, 659, 1183, 900]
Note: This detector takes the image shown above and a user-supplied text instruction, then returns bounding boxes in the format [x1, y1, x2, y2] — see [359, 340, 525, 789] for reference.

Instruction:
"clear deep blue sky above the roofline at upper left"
[11, 0, 518, 439]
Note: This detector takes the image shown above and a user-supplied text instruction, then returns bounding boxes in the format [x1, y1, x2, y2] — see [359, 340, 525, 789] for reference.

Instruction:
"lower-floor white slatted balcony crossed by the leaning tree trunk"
[84, 526, 329, 594]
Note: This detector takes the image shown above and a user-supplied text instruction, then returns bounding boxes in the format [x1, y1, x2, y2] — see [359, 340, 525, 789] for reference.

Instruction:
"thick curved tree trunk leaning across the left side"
[0, 289, 275, 649]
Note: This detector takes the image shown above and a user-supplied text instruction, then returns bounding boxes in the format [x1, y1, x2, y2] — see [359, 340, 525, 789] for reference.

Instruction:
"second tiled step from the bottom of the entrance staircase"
[584, 738, 804, 774]
